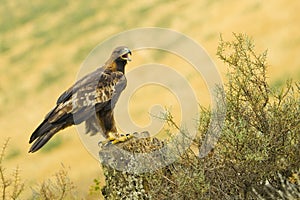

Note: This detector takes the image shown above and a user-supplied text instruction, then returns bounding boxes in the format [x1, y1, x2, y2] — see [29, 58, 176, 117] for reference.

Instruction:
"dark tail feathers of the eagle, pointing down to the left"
[29, 119, 63, 153]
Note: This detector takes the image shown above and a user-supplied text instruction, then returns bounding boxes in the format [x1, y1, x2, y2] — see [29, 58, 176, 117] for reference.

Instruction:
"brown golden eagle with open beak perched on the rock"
[29, 46, 131, 152]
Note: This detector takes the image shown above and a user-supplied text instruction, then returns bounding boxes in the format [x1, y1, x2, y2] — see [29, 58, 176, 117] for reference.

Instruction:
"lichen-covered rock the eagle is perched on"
[99, 132, 163, 199]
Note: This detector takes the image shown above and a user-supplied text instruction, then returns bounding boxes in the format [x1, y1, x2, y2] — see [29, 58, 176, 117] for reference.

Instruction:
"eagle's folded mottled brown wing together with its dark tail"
[29, 68, 126, 152]
